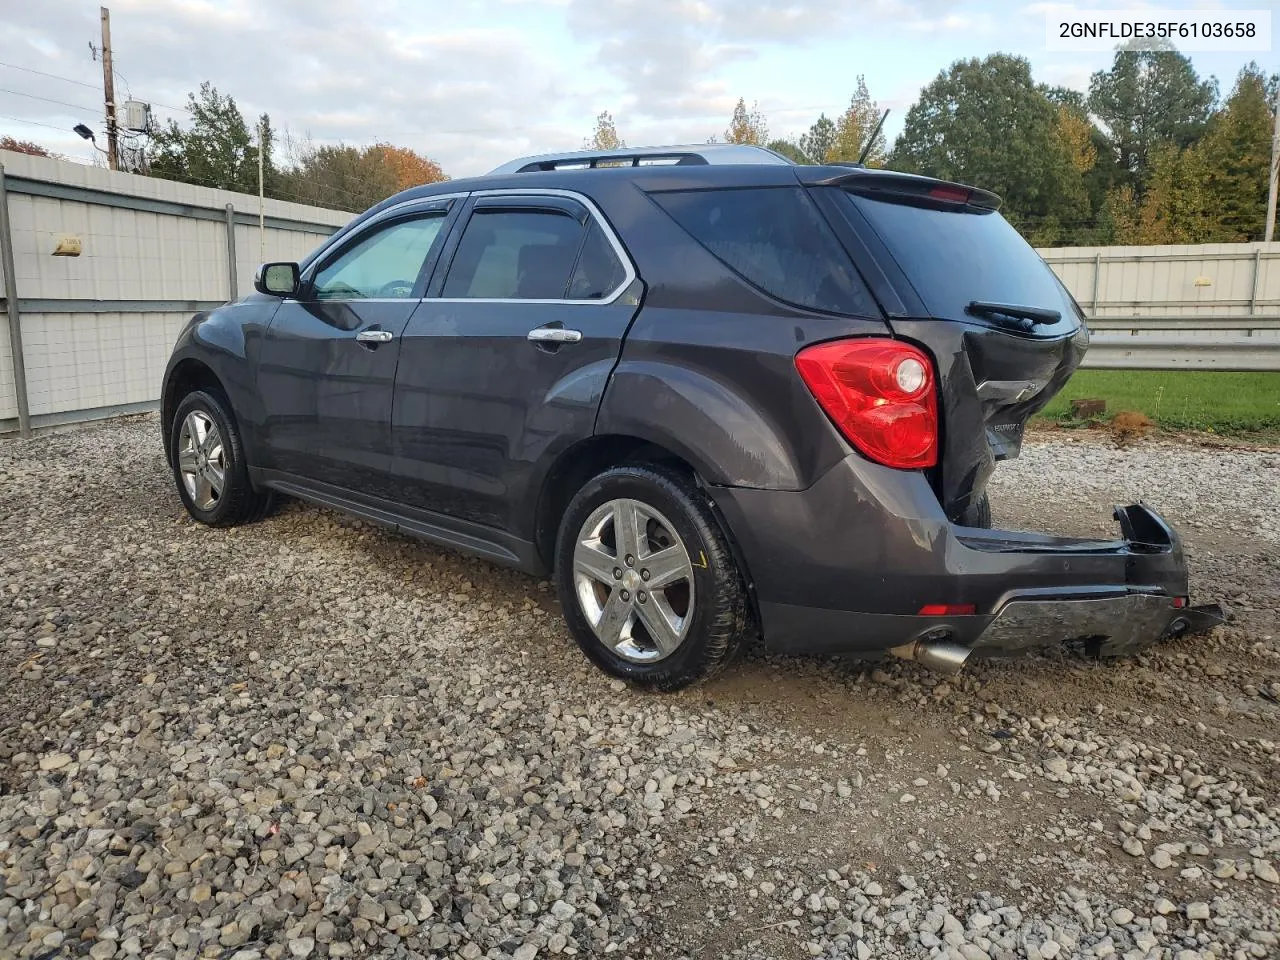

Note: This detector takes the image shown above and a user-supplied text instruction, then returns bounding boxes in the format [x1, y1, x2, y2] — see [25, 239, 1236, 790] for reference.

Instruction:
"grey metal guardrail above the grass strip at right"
[1084, 316, 1280, 371]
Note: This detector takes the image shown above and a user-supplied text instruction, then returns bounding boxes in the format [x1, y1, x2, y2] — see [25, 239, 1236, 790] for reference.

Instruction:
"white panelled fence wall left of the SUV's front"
[0, 151, 352, 430]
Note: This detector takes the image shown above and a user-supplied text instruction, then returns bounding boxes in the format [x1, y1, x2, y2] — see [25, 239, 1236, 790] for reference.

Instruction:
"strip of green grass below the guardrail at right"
[1041, 370, 1280, 434]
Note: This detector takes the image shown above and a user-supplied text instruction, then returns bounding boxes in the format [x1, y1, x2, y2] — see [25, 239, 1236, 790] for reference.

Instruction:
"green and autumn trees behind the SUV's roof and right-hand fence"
[588, 49, 1280, 247]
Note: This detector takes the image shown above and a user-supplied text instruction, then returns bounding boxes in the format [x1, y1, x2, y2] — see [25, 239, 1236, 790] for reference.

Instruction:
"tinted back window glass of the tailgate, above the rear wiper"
[845, 192, 1075, 323]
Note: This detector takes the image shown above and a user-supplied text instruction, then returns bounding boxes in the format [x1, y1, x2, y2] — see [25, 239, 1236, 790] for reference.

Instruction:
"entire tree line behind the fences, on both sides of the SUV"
[0, 47, 1280, 246]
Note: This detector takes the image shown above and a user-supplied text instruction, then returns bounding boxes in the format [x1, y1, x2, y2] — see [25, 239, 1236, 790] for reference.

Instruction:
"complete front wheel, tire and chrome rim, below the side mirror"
[169, 390, 274, 526]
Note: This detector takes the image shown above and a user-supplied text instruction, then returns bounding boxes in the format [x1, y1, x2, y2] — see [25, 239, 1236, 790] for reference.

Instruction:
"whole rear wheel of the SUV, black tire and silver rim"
[556, 465, 749, 690]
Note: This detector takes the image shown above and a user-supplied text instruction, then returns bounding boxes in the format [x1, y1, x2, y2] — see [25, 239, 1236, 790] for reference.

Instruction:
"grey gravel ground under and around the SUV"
[0, 417, 1280, 960]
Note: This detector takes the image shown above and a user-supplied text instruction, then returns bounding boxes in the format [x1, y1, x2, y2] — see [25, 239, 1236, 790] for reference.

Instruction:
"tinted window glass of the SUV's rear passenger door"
[442, 209, 582, 300]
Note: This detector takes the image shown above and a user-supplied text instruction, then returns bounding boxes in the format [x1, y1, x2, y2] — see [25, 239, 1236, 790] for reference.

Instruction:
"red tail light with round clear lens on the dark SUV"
[796, 337, 938, 470]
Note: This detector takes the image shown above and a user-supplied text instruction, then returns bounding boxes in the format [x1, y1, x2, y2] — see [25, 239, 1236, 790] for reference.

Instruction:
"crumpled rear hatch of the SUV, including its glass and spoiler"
[805, 168, 1088, 518]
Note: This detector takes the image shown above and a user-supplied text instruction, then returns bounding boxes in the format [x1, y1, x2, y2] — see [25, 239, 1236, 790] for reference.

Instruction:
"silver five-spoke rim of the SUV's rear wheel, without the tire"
[573, 499, 694, 663]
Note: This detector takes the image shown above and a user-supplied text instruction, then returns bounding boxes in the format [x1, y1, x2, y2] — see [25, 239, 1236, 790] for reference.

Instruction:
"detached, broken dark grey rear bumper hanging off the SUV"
[710, 454, 1224, 655]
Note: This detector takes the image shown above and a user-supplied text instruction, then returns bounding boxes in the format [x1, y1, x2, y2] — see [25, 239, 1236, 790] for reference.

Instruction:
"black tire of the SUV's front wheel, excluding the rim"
[169, 389, 275, 526]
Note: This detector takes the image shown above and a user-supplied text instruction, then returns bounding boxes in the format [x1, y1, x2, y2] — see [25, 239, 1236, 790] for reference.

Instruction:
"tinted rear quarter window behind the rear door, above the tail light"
[650, 187, 878, 316]
